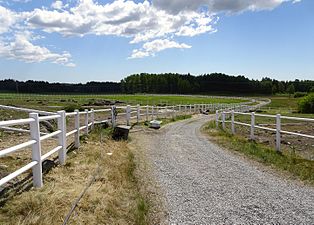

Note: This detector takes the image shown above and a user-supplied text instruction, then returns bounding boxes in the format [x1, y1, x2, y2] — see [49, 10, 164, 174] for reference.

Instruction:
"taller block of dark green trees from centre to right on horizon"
[121, 73, 314, 95]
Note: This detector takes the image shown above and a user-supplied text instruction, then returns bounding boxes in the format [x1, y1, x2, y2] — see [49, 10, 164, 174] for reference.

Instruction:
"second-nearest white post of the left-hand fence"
[58, 111, 67, 165]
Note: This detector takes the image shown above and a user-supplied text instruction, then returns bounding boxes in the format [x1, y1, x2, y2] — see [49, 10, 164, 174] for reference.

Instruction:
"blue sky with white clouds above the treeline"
[0, 0, 314, 83]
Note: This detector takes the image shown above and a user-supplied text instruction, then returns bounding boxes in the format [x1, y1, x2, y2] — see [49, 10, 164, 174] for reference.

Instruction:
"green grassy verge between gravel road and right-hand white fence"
[204, 122, 314, 184]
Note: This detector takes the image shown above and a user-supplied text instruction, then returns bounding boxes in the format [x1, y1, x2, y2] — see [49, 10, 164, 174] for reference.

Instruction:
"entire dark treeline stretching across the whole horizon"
[0, 73, 314, 95]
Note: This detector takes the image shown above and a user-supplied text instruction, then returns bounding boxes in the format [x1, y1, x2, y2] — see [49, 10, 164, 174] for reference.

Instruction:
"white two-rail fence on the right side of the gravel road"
[216, 110, 314, 152]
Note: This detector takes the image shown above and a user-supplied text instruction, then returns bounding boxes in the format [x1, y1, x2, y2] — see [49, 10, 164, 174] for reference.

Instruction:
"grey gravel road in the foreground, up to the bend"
[137, 115, 314, 224]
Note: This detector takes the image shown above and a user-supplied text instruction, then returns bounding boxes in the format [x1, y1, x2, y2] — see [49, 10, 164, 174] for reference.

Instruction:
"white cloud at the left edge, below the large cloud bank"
[0, 32, 75, 67]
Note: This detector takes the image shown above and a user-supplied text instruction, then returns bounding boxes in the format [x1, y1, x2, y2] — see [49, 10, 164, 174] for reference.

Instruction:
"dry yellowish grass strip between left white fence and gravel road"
[0, 125, 149, 225]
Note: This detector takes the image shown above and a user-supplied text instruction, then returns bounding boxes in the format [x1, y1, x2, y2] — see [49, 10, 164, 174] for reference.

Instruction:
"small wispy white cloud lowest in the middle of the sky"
[129, 39, 192, 59]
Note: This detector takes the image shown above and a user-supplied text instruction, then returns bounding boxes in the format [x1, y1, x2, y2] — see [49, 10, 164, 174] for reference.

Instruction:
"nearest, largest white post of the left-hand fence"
[29, 113, 43, 188]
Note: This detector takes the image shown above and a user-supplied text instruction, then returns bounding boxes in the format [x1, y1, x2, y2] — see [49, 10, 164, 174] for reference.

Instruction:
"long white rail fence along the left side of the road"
[0, 104, 240, 187]
